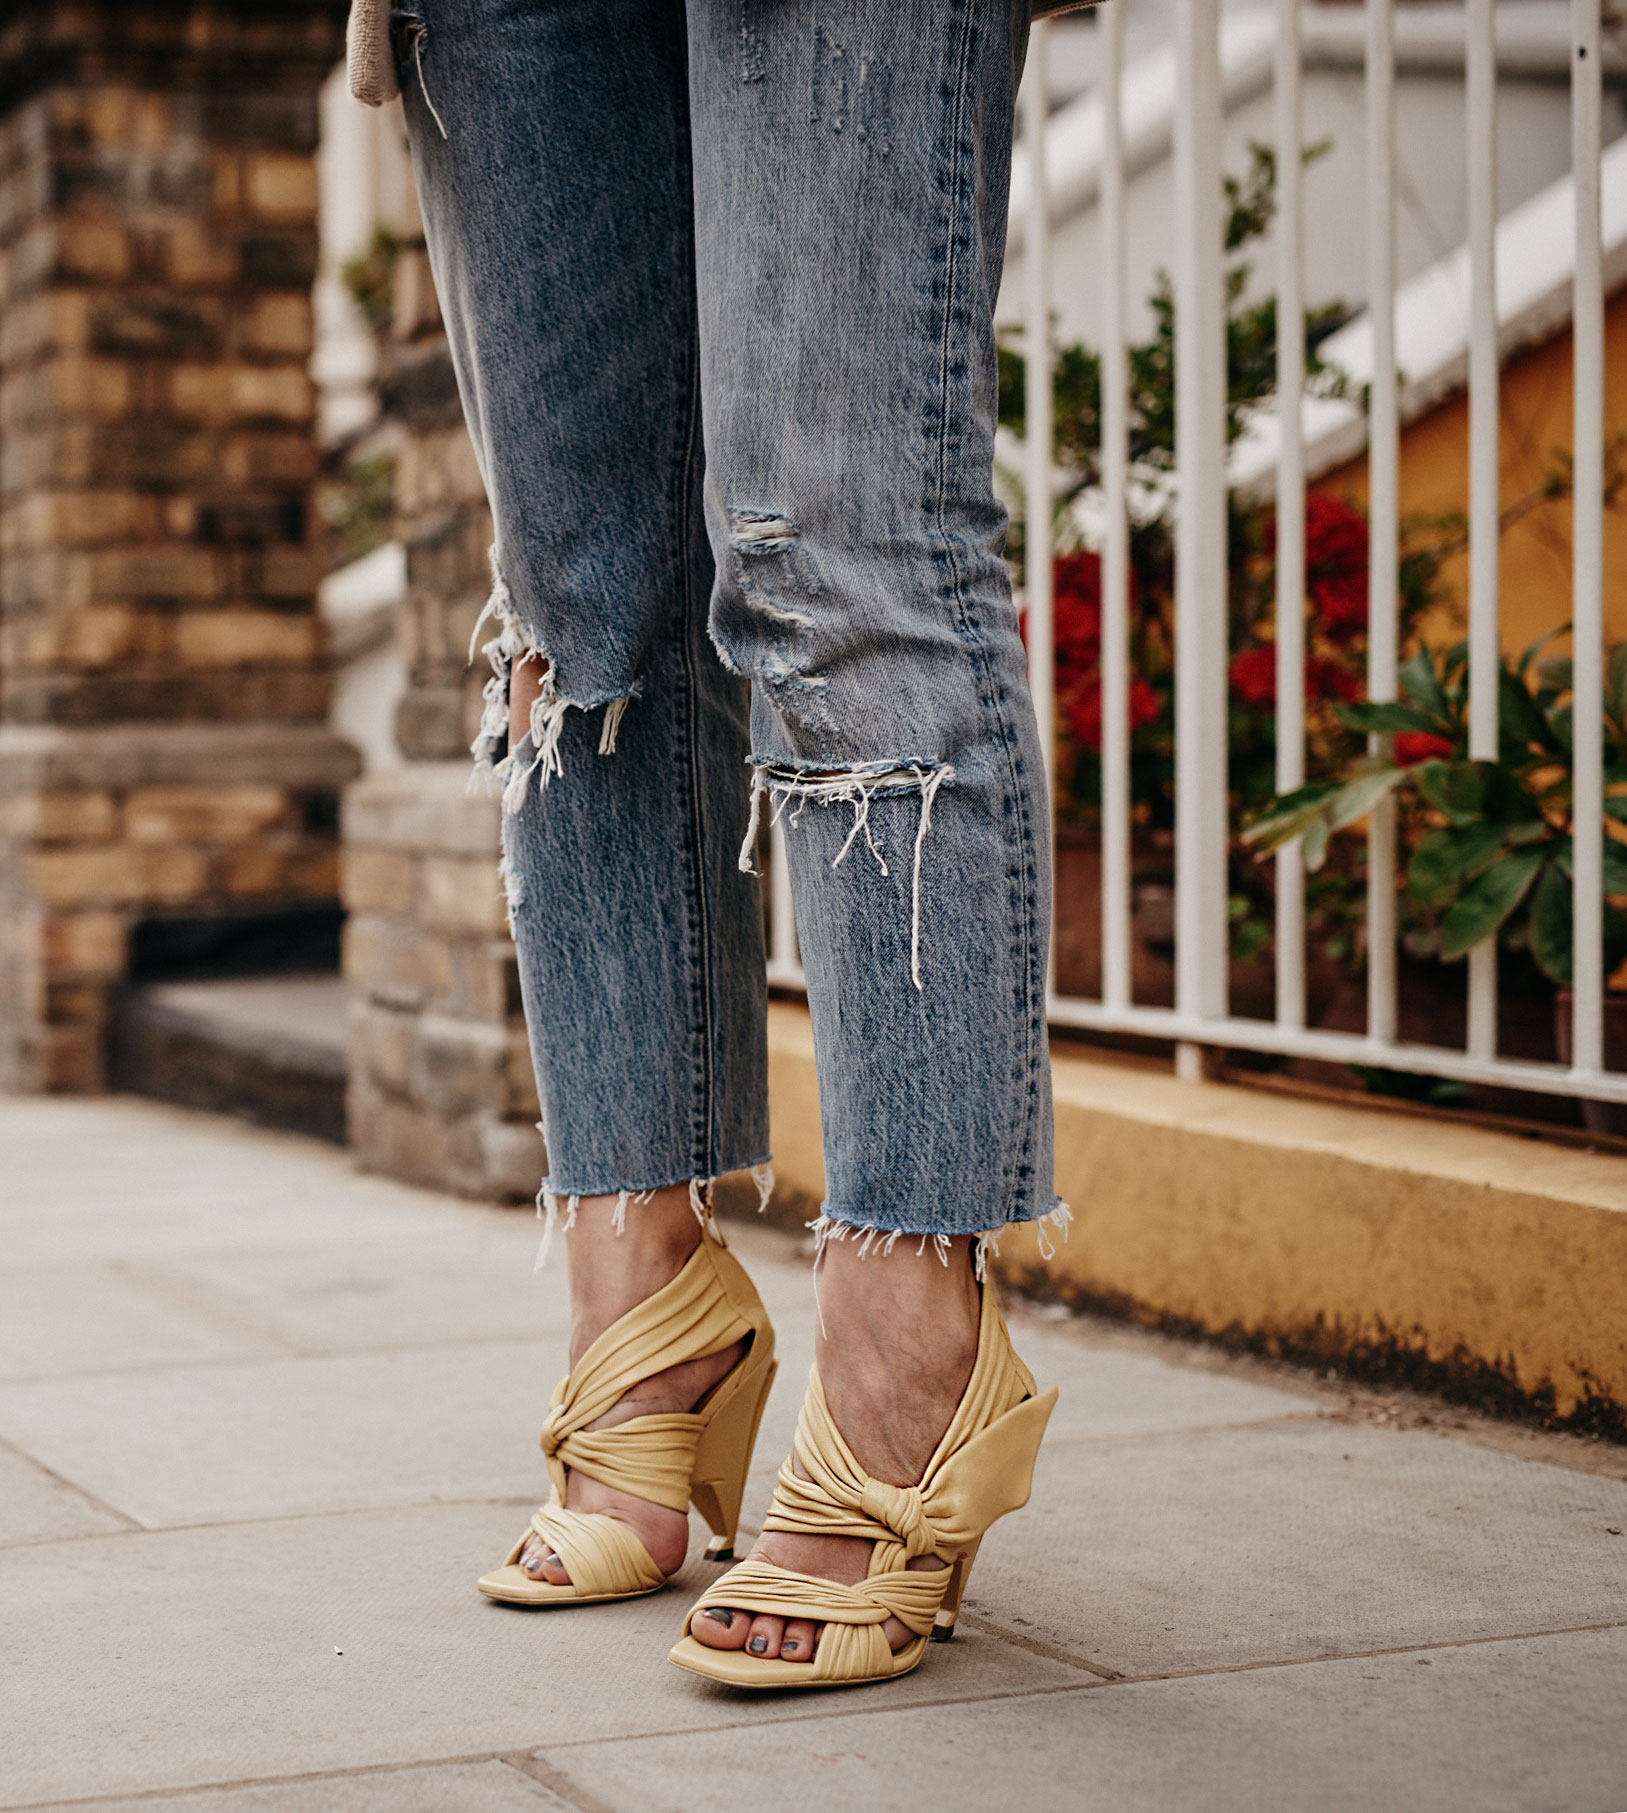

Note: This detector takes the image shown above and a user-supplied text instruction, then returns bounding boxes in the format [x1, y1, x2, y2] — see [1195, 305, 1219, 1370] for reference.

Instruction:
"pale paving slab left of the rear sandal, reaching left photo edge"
[0, 1342, 559, 1528]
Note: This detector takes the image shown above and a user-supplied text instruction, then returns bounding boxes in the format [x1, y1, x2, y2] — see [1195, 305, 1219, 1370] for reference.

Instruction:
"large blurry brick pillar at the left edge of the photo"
[0, 0, 357, 1088]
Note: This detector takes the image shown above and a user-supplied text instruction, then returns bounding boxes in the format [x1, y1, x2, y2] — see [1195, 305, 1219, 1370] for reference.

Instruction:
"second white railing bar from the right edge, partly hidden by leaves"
[1464, 0, 1500, 1059]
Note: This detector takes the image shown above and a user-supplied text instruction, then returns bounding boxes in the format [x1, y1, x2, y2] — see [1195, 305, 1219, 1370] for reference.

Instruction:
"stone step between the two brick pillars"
[109, 970, 345, 1144]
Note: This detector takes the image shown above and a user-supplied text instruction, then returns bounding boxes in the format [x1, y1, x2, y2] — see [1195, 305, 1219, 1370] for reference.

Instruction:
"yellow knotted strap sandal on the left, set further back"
[477, 1229, 776, 1606]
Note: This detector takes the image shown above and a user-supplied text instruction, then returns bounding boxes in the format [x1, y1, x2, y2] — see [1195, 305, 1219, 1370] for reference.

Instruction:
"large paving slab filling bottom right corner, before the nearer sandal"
[542, 1630, 1627, 1813]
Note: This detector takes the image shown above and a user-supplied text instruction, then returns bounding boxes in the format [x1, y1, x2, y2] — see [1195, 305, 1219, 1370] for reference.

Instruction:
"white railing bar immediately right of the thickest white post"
[1275, 0, 1306, 1026]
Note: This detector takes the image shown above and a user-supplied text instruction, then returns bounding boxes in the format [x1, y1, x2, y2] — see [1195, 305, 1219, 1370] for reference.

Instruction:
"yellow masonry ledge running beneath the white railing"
[754, 1004, 1627, 1432]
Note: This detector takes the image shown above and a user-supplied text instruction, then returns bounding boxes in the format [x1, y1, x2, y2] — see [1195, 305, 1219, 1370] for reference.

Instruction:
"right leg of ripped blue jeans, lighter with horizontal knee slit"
[687, 0, 1067, 1244]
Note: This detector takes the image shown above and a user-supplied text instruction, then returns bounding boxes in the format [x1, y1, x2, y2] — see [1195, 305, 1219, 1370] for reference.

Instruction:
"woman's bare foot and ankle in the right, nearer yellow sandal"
[689, 1240, 981, 1663]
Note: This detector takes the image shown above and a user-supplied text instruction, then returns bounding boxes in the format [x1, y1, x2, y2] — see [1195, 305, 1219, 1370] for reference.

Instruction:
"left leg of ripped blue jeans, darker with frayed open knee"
[395, 0, 767, 1218]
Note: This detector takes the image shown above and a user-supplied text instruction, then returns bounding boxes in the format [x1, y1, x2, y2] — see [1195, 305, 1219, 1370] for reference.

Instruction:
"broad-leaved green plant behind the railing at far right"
[1244, 631, 1627, 986]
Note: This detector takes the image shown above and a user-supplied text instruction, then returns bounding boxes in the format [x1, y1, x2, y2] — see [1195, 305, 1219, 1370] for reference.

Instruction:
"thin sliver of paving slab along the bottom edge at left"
[22, 1759, 575, 1813]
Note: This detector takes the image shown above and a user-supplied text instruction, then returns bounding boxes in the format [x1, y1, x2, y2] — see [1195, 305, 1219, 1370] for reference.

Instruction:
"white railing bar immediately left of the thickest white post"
[1097, 4, 1130, 1008]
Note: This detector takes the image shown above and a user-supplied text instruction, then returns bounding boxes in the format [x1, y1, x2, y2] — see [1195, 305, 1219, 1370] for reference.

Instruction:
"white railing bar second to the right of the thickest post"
[1366, 0, 1400, 1044]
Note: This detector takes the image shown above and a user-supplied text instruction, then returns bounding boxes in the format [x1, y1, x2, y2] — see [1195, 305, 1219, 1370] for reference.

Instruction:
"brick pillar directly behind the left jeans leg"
[343, 176, 546, 1200]
